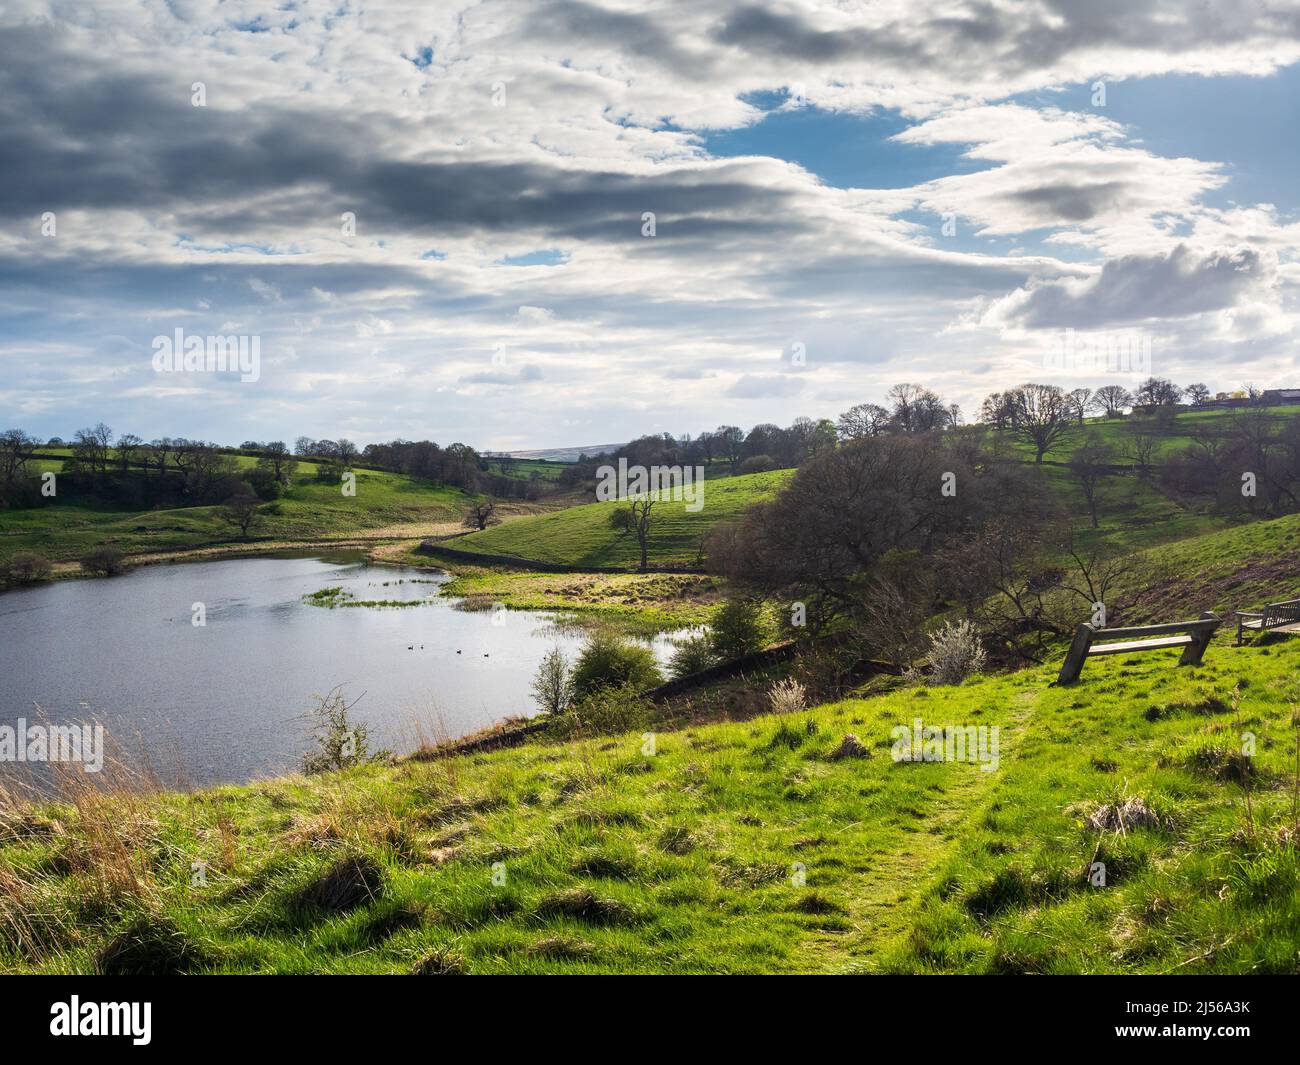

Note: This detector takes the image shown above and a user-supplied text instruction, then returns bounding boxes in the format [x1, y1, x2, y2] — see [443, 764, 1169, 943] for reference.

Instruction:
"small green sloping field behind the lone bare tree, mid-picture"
[451, 469, 794, 568]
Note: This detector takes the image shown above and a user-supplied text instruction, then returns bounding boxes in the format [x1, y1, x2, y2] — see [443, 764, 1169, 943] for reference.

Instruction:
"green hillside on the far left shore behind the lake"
[0, 459, 469, 562]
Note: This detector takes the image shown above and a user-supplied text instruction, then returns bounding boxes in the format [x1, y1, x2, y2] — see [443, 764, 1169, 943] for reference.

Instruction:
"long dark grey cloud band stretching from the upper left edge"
[0, 26, 792, 242]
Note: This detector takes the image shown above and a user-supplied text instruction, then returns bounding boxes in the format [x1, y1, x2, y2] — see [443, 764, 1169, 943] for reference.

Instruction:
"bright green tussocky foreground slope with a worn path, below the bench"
[0, 631, 1300, 973]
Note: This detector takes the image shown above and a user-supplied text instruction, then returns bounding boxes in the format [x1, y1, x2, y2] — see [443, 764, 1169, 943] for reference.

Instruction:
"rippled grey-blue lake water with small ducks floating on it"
[0, 555, 686, 784]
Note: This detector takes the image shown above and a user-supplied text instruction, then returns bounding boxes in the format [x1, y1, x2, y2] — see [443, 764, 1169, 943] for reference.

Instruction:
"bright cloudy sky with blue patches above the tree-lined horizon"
[0, 0, 1300, 449]
